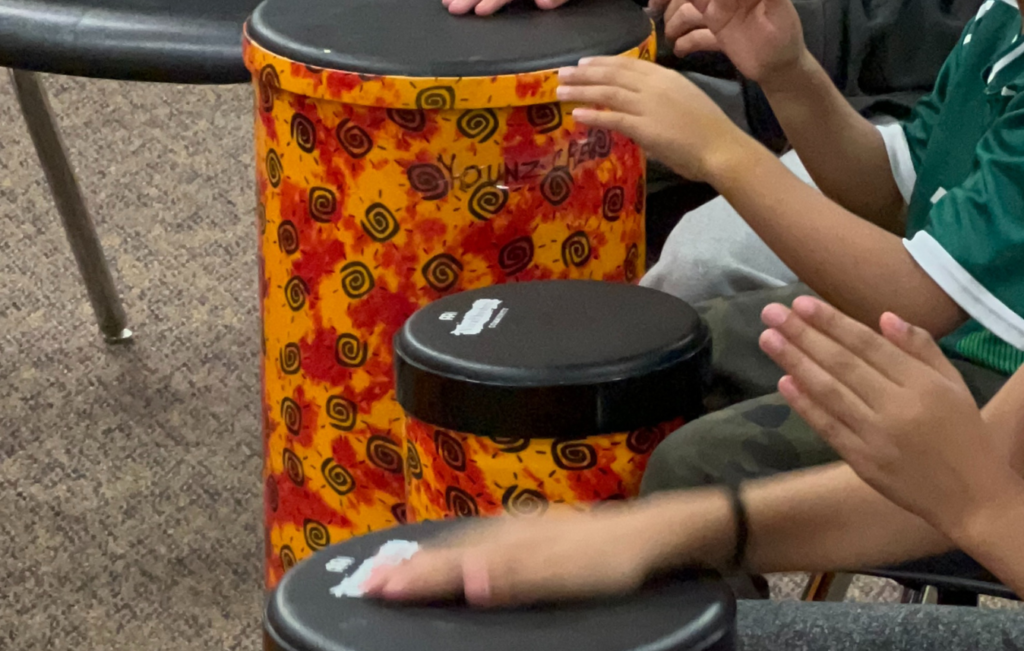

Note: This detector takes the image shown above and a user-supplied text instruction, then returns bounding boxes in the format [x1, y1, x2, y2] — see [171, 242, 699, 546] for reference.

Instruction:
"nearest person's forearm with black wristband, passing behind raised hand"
[645, 465, 953, 572]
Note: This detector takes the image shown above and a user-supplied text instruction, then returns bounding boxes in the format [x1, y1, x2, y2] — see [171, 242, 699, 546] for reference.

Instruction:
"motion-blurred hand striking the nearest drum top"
[362, 505, 656, 606]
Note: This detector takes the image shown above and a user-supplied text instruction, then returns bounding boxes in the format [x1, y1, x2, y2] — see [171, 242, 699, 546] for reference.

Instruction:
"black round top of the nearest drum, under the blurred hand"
[265, 522, 735, 651]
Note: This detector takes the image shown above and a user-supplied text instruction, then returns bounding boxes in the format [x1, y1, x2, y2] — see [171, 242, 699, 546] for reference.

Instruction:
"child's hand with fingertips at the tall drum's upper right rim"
[558, 56, 754, 181]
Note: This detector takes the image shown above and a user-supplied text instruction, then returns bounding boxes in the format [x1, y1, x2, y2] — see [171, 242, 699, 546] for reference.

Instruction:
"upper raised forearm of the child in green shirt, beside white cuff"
[761, 51, 903, 232]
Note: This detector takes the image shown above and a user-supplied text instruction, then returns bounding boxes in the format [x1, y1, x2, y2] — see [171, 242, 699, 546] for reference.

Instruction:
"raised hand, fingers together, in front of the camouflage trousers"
[761, 297, 1024, 540]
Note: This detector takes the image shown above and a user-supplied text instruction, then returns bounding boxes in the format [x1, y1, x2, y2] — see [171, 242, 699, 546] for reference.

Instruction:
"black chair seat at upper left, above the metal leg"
[0, 0, 259, 84]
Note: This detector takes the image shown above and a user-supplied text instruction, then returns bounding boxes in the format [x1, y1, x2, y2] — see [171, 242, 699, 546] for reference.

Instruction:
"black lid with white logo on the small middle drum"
[394, 280, 711, 438]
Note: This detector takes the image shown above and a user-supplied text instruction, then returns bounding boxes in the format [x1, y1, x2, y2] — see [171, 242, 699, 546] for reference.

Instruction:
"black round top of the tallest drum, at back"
[248, 0, 651, 77]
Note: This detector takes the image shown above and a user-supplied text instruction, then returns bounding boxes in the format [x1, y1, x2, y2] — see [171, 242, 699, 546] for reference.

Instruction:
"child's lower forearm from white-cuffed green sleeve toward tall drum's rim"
[709, 140, 967, 337]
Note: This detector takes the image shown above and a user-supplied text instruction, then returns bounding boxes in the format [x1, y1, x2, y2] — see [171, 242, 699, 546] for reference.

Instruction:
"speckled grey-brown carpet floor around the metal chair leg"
[0, 72, 1007, 651]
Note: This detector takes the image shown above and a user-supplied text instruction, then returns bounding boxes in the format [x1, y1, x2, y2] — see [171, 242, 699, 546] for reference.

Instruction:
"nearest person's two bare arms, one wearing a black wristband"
[365, 297, 1024, 610]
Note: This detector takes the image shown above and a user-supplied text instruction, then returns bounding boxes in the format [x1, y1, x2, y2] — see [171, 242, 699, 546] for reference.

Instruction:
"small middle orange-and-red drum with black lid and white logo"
[395, 281, 711, 521]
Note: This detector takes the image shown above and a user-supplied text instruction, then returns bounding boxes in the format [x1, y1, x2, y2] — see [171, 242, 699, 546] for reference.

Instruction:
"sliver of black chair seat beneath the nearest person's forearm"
[863, 552, 1019, 600]
